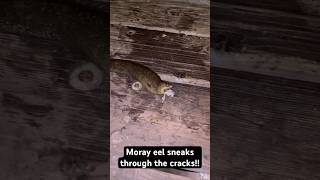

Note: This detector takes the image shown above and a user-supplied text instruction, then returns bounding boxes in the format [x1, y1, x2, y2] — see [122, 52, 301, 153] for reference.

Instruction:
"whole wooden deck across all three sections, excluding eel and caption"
[0, 0, 320, 180]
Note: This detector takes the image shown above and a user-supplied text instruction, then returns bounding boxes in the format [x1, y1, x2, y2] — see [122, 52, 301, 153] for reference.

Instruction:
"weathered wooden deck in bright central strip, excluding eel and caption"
[110, 0, 210, 180]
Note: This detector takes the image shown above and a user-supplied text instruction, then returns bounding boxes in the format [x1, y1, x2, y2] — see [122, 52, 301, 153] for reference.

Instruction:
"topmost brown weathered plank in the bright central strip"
[110, 0, 210, 37]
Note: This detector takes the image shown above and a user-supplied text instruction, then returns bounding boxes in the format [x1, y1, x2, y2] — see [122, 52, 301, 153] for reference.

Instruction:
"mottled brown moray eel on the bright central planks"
[110, 60, 171, 94]
